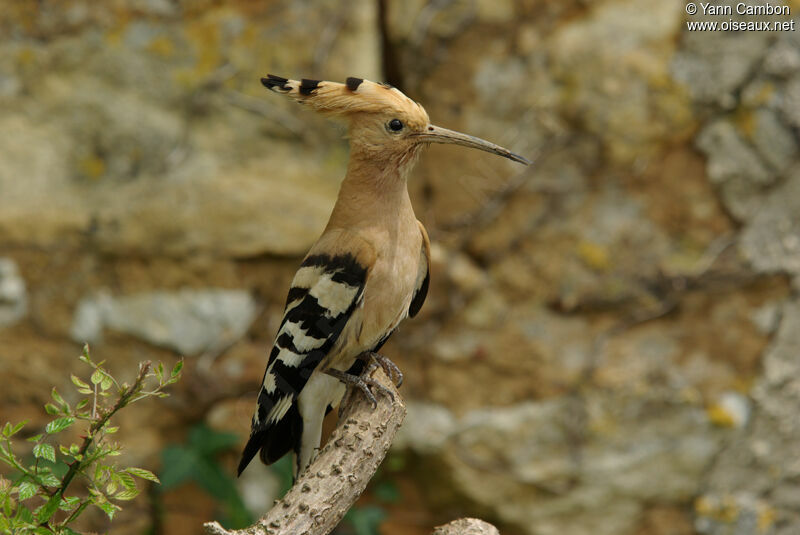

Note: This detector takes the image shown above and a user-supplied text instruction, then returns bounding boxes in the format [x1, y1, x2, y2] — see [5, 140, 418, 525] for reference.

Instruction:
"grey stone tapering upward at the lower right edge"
[695, 301, 800, 535]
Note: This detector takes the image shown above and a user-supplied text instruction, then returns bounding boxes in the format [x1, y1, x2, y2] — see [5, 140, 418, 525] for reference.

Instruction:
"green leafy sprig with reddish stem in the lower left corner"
[0, 345, 183, 535]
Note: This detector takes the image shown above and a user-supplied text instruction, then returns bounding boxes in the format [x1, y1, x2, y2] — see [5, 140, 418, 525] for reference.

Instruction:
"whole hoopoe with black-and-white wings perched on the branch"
[234, 75, 530, 477]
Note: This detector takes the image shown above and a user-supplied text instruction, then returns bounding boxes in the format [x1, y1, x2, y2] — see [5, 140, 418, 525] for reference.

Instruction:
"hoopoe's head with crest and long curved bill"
[261, 74, 531, 170]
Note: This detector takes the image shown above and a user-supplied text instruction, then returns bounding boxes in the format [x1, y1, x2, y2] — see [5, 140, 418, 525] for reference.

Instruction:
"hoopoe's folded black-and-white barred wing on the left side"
[239, 253, 368, 474]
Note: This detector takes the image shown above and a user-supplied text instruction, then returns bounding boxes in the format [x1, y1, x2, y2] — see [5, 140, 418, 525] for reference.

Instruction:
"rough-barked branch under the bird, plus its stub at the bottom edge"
[204, 367, 498, 535]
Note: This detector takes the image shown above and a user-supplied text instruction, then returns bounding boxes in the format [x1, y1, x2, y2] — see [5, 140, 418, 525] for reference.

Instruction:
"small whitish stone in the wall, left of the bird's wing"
[71, 289, 257, 355]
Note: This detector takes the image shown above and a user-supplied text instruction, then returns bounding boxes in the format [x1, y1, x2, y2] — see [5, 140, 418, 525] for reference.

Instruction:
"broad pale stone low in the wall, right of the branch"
[394, 393, 724, 535]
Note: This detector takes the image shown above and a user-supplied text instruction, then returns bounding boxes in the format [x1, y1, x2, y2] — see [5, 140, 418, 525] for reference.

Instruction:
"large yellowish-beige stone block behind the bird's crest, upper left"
[0, 1, 380, 256]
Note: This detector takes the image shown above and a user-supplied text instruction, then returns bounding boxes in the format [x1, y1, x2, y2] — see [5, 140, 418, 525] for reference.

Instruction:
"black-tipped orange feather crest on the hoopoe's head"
[261, 74, 428, 128]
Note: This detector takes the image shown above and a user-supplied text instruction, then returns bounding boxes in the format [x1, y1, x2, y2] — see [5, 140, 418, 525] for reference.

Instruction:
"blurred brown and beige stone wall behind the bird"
[0, 0, 800, 535]
